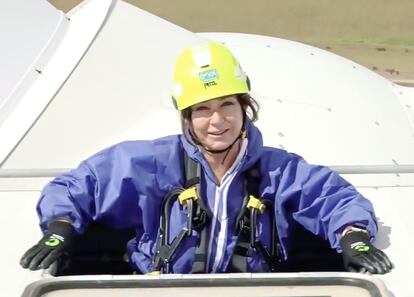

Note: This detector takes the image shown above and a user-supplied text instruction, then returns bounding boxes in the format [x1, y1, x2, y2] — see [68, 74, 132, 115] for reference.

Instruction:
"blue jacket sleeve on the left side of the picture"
[37, 142, 162, 233]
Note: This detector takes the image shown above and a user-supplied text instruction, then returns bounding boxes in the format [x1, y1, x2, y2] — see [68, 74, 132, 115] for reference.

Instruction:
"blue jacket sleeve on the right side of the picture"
[278, 154, 377, 251]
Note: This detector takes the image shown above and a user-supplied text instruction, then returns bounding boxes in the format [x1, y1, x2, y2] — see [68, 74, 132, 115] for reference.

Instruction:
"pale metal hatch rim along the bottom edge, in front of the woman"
[22, 273, 390, 297]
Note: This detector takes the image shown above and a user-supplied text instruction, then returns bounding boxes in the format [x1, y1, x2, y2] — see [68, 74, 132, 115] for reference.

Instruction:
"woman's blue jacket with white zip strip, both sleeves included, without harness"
[37, 123, 377, 273]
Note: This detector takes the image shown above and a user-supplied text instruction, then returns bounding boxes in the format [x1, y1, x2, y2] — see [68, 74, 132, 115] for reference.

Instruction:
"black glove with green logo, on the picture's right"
[340, 231, 393, 274]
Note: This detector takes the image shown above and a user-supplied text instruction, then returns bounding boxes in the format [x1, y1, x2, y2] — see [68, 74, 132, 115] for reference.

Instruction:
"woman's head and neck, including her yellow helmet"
[173, 42, 252, 184]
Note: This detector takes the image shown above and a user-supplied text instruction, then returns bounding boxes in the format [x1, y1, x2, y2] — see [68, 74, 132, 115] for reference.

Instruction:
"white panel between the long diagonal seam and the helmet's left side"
[3, 0, 201, 168]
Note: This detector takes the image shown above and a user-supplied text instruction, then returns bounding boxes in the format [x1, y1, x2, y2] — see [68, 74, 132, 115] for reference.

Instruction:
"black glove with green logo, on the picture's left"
[20, 221, 73, 270]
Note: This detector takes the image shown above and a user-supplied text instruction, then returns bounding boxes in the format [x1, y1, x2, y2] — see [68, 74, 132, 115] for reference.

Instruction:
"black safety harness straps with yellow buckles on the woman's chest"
[152, 152, 280, 274]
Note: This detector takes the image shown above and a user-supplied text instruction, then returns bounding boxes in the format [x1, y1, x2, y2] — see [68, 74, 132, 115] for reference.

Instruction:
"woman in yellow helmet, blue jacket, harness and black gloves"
[21, 42, 392, 273]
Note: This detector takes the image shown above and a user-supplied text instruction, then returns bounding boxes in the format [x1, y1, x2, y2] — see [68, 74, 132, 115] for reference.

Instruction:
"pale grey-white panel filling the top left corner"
[0, 0, 63, 110]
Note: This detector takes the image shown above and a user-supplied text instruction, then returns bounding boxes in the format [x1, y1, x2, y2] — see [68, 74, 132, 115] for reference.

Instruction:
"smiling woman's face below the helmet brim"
[191, 95, 243, 150]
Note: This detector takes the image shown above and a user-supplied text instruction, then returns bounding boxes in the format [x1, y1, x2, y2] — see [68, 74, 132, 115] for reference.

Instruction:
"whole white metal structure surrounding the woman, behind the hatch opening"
[0, 0, 414, 297]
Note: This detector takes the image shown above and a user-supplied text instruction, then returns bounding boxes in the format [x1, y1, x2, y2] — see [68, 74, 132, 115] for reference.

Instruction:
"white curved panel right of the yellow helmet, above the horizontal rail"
[202, 33, 414, 165]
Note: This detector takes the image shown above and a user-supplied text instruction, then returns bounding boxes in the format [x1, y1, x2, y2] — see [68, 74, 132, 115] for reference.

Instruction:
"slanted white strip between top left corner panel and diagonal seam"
[0, 0, 112, 165]
